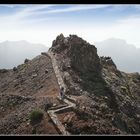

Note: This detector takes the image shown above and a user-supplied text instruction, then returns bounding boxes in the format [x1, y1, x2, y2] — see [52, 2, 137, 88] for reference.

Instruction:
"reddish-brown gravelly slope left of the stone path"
[0, 53, 60, 134]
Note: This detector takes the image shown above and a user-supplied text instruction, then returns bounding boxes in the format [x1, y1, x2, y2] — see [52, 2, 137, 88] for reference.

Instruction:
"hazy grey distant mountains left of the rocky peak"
[0, 40, 47, 69]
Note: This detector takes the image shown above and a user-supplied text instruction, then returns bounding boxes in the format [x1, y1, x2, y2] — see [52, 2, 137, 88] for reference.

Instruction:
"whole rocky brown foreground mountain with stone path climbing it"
[0, 34, 140, 135]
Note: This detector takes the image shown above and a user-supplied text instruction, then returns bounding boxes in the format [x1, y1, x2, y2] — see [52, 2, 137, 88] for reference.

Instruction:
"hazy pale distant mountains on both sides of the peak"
[0, 38, 140, 73]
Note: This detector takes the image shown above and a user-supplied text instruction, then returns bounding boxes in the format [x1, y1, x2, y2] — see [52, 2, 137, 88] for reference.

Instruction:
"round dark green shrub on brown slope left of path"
[30, 109, 43, 122]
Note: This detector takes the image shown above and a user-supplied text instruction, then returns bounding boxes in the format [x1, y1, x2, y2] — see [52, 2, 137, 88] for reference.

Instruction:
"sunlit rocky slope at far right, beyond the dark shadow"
[101, 57, 140, 134]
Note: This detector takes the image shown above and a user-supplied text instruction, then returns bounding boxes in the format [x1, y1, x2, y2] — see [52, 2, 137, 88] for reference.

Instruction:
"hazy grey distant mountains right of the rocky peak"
[95, 38, 140, 72]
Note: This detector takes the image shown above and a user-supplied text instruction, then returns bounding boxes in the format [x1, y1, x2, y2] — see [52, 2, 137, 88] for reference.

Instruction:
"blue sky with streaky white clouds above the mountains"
[0, 4, 140, 48]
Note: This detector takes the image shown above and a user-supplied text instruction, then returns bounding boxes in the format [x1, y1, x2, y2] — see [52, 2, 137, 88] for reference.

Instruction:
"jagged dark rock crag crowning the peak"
[50, 34, 101, 74]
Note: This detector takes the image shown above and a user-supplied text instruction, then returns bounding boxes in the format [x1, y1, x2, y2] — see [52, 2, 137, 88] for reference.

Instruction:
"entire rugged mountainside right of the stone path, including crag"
[49, 34, 140, 134]
